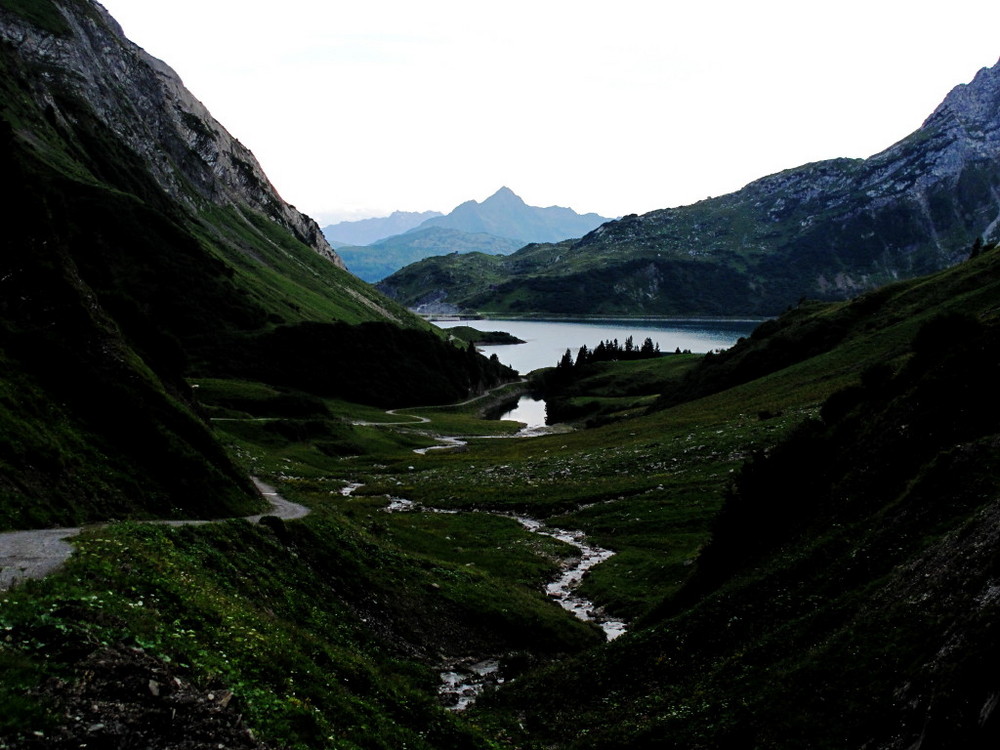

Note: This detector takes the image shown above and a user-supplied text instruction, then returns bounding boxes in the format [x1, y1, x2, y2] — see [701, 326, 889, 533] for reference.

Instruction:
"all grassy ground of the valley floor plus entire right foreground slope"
[7, 242, 1000, 748]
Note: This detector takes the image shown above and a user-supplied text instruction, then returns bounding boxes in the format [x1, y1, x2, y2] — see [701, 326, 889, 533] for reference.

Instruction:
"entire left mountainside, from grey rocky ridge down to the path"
[0, 0, 509, 527]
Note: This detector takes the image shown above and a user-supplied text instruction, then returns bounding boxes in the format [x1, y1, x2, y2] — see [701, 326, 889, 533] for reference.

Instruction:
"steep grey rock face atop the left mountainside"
[0, 0, 343, 268]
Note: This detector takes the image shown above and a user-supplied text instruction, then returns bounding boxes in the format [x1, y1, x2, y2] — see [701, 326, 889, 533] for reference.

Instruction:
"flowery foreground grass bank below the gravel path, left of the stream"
[0, 502, 599, 748]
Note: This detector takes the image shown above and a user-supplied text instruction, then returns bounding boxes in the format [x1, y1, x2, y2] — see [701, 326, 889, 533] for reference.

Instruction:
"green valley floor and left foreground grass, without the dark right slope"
[0, 348, 844, 750]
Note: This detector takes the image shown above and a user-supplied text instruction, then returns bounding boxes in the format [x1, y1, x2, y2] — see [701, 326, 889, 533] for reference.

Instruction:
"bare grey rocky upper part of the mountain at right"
[620, 57, 1000, 280]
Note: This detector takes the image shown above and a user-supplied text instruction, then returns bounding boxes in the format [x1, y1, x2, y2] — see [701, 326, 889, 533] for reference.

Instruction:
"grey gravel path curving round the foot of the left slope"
[0, 477, 309, 591]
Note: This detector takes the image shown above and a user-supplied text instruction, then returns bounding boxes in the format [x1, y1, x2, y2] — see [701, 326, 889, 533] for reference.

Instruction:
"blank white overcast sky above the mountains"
[102, 0, 1000, 225]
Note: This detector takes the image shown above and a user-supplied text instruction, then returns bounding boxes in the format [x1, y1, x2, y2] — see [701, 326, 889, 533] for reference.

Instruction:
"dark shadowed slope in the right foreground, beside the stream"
[472, 250, 1000, 748]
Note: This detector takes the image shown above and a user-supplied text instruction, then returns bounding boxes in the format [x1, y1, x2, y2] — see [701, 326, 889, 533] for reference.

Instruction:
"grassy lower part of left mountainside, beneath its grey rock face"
[0, 92, 461, 526]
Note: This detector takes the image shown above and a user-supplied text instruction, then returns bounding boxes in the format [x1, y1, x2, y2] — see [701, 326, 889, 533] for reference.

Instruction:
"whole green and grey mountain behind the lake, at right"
[379, 60, 1000, 315]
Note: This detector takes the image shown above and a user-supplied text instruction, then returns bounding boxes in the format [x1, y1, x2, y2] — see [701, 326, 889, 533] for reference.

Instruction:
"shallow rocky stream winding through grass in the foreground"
[378, 496, 626, 711]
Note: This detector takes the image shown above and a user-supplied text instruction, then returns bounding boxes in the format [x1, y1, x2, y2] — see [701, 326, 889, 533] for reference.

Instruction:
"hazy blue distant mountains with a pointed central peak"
[323, 187, 610, 282]
